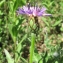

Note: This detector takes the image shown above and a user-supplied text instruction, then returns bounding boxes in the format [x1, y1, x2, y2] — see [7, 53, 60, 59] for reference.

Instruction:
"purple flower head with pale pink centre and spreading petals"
[17, 6, 51, 17]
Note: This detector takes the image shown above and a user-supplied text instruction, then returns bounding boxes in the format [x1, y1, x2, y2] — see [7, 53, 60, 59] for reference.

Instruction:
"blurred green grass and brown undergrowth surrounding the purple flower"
[0, 0, 63, 63]
